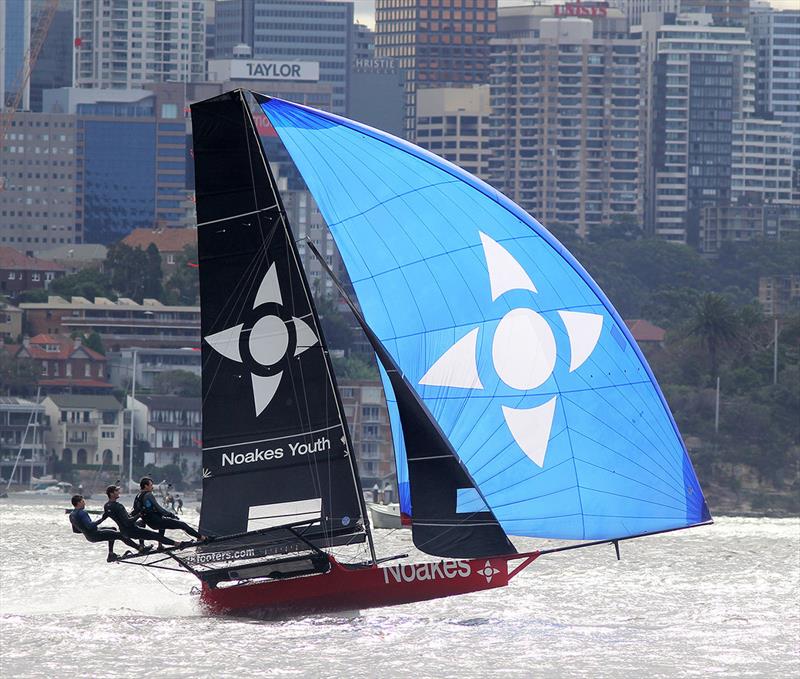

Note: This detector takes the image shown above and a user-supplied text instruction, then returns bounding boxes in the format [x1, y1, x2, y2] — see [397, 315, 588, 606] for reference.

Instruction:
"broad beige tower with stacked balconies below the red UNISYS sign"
[490, 8, 643, 236]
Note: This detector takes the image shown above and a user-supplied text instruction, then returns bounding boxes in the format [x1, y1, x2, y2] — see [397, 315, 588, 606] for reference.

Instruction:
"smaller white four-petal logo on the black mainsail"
[204, 263, 319, 416]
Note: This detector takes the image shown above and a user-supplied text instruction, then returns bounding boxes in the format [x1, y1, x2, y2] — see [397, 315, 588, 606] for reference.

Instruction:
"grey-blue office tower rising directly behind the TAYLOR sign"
[215, 0, 353, 114]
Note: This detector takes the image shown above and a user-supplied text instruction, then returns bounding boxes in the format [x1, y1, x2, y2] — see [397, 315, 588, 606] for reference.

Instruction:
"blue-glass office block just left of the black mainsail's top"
[44, 83, 188, 243]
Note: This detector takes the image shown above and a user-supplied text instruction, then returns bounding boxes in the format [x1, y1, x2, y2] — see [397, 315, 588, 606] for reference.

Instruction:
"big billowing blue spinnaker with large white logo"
[262, 99, 710, 539]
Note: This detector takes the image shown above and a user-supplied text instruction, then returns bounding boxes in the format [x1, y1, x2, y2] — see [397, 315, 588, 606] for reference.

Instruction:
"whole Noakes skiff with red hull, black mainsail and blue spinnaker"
[117, 90, 710, 616]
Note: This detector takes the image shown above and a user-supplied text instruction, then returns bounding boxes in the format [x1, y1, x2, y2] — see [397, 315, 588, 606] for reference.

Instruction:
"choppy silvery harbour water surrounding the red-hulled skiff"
[0, 496, 800, 679]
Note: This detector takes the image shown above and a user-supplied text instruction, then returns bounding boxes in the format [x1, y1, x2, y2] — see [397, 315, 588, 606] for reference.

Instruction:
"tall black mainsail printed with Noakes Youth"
[192, 92, 364, 546]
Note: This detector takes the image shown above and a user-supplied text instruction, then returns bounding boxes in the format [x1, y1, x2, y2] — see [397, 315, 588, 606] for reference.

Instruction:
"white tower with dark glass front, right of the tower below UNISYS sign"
[638, 14, 755, 243]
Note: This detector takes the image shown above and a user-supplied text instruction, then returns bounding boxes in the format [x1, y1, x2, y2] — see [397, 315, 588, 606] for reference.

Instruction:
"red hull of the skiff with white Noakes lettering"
[201, 552, 539, 618]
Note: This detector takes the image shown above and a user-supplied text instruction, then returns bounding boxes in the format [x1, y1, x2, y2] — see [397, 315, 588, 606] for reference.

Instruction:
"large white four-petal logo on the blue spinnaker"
[419, 233, 603, 467]
